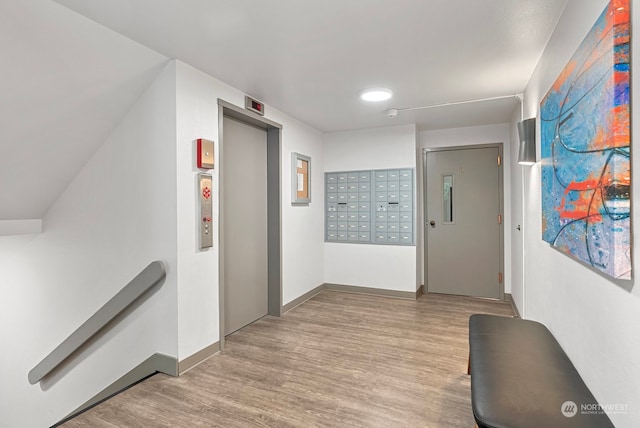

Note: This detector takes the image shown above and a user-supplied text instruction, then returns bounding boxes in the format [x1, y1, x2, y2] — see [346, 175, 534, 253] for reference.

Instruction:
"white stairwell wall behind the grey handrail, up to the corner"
[0, 61, 177, 427]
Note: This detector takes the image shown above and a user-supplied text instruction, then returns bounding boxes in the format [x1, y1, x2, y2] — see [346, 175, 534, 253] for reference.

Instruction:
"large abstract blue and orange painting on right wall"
[540, 0, 631, 279]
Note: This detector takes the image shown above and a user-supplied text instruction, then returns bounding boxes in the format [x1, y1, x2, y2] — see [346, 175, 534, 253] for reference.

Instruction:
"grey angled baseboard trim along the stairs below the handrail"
[52, 354, 178, 428]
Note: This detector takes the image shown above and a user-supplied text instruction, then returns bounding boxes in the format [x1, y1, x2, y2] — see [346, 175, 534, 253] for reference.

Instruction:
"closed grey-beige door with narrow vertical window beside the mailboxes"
[425, 147, 502, 298]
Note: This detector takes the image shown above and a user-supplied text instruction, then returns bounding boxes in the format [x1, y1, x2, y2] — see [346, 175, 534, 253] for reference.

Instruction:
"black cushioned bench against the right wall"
[469, 314, 613, 428]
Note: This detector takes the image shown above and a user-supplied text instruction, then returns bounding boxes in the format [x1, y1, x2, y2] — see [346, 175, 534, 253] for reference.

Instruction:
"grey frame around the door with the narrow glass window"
[422, 143, 506, 301]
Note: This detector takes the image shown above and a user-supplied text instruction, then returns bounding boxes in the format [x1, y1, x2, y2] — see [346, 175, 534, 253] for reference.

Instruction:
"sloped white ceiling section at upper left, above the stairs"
[0, 0, 168, 220]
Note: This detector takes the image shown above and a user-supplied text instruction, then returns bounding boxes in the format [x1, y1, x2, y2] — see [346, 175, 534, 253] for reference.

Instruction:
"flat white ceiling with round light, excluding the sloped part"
[57, 0, 566, 132]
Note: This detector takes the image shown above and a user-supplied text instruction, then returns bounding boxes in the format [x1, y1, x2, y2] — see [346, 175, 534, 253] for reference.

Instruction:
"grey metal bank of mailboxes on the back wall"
[325, 169, 414, 245]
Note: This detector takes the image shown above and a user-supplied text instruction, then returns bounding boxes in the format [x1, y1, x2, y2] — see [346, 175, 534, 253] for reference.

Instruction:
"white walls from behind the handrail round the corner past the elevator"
[0, 57, 324, 427]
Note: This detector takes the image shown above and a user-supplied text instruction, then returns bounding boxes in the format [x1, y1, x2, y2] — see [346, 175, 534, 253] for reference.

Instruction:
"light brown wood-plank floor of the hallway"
[62, 291, 513, 428]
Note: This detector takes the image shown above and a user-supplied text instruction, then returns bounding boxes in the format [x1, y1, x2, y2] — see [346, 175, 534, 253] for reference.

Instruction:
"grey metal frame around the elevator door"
[217, 99, 282, 351]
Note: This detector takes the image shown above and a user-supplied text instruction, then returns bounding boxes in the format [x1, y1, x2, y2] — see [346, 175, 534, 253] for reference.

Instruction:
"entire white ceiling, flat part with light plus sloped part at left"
[0, 0, 566, 220]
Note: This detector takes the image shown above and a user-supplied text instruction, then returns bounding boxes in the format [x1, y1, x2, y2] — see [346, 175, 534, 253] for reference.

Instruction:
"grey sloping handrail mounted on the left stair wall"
[29, 261, 166, 385]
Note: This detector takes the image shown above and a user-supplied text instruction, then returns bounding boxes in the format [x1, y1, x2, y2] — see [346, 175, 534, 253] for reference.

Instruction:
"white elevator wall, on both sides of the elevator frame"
[176, 61, 324, 360]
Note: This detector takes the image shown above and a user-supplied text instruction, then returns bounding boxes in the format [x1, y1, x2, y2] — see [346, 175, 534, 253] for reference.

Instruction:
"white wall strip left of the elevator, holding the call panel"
[176, 61, 232, 360]
